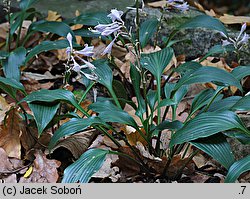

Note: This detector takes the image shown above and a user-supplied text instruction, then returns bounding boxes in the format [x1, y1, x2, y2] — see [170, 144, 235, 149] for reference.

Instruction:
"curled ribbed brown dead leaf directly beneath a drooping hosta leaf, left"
[52, 129, 97, 159]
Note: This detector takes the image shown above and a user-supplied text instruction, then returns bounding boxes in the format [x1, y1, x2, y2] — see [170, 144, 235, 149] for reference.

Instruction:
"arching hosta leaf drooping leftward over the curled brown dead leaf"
[49, 117, 103, 150]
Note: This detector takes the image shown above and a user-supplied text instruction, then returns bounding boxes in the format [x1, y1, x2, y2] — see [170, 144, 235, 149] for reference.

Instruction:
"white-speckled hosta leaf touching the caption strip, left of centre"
[62, 149, 109, 183]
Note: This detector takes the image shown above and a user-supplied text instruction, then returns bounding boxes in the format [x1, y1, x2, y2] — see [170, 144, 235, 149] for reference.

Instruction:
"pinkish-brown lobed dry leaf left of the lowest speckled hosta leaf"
[20, 151, 61, 183]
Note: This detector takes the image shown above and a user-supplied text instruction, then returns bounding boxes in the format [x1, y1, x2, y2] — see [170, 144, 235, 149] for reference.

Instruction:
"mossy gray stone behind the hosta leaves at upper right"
[125, 7, 250, 65]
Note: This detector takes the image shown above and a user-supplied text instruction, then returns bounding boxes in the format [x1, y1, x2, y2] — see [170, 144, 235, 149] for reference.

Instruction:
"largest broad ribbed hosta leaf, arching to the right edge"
[170, 111, 250, 147]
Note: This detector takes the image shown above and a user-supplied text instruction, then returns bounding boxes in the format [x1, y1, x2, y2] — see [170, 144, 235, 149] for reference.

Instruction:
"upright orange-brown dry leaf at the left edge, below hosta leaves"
[0, 109, 23, 159]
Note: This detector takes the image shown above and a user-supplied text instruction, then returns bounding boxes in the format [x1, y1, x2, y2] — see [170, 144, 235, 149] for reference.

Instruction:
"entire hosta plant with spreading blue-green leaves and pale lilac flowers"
[0, 1, 250, 183]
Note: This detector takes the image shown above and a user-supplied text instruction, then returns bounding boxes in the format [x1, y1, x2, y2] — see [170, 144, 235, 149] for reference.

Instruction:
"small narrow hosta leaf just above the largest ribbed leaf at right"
[208, 96, 241, 112]
